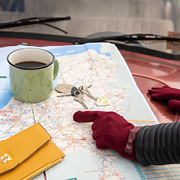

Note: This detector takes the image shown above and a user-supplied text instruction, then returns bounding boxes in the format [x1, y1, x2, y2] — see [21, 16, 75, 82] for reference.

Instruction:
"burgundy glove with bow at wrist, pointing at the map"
[73, 111, 140, 161]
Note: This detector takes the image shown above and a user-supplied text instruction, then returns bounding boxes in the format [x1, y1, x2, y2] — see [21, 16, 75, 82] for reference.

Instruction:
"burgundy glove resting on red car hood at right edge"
[148, 86, 180, 112]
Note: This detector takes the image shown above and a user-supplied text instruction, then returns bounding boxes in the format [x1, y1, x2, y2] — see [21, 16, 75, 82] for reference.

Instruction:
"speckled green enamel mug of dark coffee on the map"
[7, 48, 59, 103]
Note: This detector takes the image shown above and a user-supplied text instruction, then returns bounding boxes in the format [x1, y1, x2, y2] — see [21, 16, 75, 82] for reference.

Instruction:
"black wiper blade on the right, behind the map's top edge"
[74, 34, 180, 44]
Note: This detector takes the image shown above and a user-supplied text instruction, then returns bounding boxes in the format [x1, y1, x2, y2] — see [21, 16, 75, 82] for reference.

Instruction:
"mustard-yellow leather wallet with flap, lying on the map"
[0, 123, 65, 180]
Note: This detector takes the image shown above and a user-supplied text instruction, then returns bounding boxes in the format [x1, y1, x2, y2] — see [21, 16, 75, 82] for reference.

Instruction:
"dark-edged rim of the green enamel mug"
[7, 48, 55, 70]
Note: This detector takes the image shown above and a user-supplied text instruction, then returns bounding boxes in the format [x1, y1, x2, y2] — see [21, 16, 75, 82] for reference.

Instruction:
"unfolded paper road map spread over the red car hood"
[0, 43, 160, 180]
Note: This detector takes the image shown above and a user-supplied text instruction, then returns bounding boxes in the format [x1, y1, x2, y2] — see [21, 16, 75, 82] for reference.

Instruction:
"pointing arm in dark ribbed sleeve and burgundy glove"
[73, 111, 180, 166]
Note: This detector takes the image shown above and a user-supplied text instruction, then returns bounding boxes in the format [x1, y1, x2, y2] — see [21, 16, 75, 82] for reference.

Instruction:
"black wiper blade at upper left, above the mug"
[0, 16, 71, 29]
